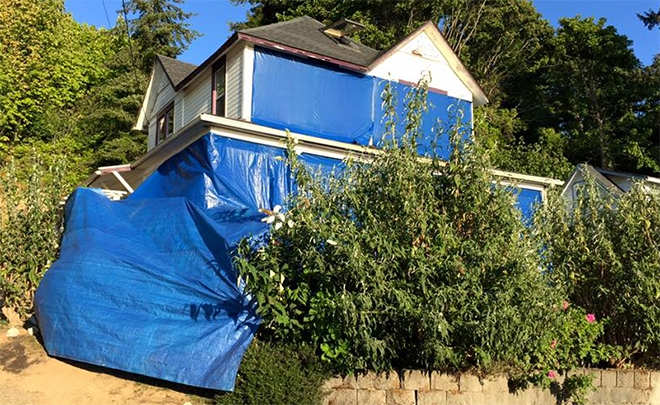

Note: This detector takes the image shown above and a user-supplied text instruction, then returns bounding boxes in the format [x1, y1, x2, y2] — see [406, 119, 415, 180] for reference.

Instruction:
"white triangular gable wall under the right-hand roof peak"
[368, 32, 473, 102]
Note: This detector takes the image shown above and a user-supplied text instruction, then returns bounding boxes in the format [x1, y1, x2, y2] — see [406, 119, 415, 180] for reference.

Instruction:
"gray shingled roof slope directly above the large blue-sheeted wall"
[239, 16, 380, 66]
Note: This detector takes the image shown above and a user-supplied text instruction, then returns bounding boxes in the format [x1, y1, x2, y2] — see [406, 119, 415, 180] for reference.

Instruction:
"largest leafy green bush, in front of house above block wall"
[237, 83, 600, 400]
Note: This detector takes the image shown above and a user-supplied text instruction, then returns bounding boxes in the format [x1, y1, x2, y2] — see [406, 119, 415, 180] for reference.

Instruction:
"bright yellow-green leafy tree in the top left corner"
[0, 0, 107, 148]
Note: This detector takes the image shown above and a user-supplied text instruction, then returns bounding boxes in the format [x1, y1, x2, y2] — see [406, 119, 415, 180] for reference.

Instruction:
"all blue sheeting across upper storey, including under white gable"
[251, 47, 472, 158]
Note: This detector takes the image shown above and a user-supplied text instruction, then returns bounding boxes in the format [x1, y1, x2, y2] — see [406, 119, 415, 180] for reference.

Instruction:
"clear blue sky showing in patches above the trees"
[65, 0, 660, 65]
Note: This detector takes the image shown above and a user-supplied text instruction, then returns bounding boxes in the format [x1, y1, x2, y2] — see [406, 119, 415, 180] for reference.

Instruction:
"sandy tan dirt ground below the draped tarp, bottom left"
[0, 327, 208, 405]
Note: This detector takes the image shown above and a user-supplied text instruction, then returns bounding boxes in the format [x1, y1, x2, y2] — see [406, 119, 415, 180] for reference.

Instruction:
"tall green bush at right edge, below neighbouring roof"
[537, 172, 660, 366]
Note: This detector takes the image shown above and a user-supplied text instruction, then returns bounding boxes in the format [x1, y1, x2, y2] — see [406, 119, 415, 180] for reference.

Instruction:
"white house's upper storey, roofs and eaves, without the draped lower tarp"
[86, 16, 562, 213]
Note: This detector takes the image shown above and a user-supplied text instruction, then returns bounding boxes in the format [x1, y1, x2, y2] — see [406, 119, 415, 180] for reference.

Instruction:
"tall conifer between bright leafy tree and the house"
[72, 0, 198, 166]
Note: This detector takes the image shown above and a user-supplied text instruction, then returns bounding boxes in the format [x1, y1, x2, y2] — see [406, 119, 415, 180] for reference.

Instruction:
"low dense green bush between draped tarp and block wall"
[215, 339, 330, 405]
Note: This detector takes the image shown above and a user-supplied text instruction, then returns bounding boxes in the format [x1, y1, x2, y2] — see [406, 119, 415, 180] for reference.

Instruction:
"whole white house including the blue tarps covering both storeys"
[35, 17, 562, 390]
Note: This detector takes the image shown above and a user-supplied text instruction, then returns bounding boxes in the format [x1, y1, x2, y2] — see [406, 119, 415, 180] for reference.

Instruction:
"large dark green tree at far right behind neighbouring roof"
[542, 16, 658, 171]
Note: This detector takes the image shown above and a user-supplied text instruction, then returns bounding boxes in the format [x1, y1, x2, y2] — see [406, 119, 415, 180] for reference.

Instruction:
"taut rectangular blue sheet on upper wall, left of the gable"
[251, 47, 380, 143]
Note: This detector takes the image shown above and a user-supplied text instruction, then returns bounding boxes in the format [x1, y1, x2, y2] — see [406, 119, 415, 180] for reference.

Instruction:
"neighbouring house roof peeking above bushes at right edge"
[562, 163, 660, 201]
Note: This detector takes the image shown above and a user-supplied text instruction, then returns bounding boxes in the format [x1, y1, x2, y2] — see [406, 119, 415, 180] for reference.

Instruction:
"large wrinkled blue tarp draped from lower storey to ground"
[35, 134, 339, 390]
